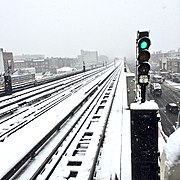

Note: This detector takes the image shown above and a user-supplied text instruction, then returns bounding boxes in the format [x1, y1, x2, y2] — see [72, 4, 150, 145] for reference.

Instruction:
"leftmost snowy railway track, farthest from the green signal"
[0, 68, 107, 109]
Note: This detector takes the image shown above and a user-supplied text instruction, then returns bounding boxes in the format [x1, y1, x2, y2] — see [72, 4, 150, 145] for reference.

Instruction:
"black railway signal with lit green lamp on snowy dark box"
[136, 31, 151, 102]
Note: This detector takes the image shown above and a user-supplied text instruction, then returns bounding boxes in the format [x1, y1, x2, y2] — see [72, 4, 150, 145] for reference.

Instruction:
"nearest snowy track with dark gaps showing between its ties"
[2, 61, 120, 180]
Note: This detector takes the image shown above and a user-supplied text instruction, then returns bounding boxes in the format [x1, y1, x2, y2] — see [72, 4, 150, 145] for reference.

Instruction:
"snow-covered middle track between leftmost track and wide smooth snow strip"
[0, 65, 114, 142]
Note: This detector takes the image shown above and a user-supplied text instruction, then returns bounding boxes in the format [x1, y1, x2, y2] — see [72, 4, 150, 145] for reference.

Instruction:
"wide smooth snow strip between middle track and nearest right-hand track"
[0, 71, 102, 177]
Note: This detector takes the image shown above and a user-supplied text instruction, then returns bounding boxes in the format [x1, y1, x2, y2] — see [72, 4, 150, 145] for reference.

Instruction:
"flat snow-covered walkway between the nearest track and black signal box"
[96, 64, 132, 180]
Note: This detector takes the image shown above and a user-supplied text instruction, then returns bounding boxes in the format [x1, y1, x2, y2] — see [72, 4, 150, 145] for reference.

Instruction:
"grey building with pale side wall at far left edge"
[0, 48, 14, 75]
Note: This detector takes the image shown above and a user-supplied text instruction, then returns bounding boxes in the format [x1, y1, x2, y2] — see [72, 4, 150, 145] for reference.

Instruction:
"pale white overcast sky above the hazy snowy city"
[0, 0, 180, 58]
